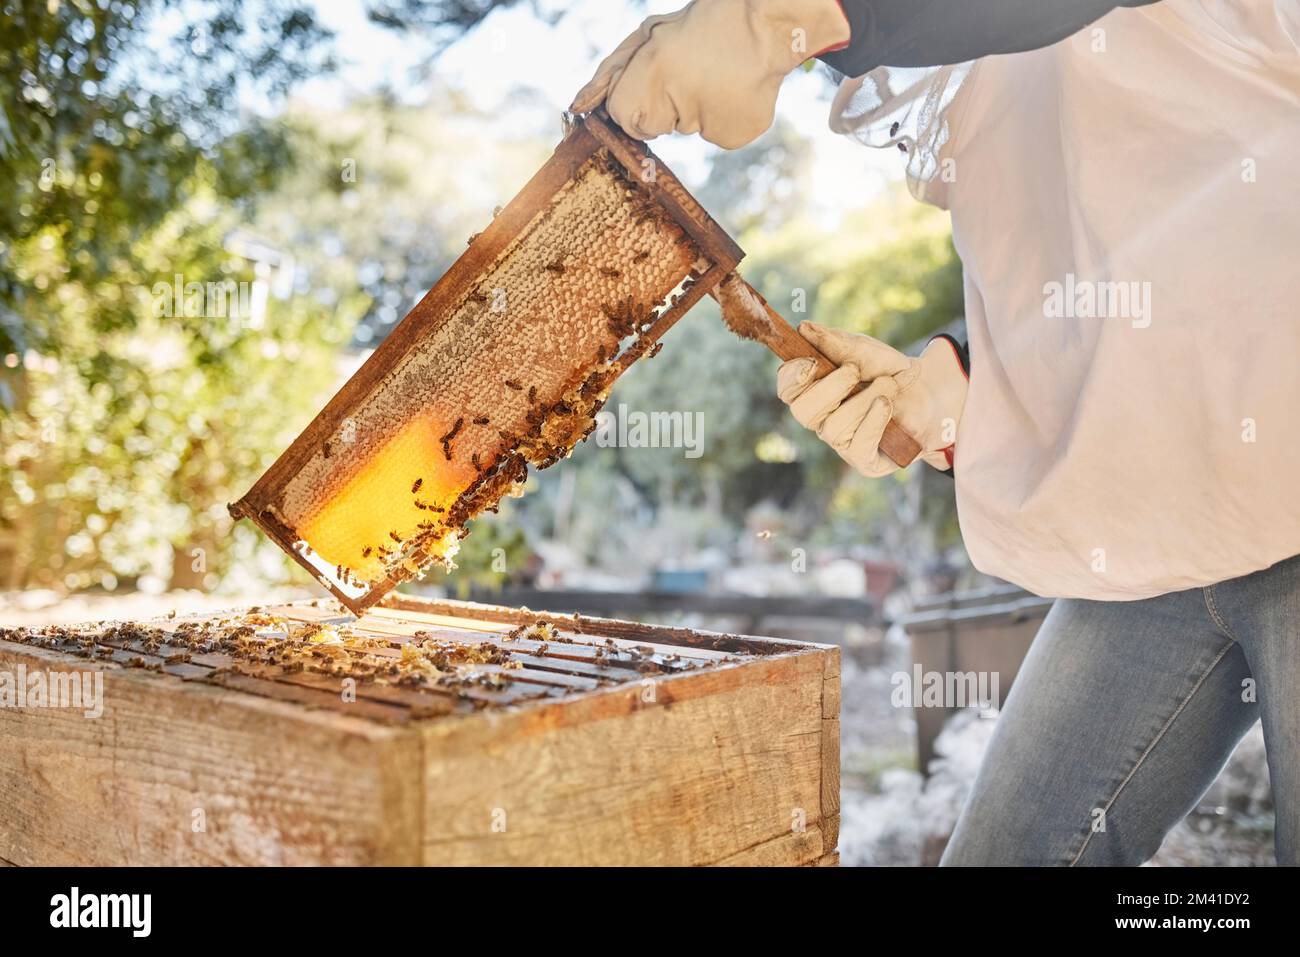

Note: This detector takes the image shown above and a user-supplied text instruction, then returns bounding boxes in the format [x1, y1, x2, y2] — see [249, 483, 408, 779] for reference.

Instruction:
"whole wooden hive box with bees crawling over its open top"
[0, 596, 840, 865]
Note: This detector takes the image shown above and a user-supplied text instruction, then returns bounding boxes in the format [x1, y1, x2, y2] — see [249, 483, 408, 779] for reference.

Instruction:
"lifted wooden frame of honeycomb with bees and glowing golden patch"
[231, 116, 742, 611]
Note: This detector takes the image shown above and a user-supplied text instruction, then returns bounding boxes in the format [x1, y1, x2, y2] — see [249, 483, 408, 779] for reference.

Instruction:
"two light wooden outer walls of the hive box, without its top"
[0, 606, 840, 865]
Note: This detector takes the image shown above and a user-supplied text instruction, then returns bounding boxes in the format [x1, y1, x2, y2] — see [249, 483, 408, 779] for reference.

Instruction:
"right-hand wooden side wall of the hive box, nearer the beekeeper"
[421, 651, 824, 865]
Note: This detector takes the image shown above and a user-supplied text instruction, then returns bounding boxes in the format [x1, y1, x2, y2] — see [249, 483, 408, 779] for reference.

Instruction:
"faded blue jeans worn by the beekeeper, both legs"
[941, 557, 1300, 866]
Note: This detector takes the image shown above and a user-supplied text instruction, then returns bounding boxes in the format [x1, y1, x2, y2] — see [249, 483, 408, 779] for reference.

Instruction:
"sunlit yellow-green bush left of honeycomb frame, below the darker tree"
[0, 183, 364, 588]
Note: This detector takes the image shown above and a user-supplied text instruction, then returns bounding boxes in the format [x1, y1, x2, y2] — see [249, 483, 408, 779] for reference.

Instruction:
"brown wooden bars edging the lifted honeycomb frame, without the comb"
[230, 112, 745, 605]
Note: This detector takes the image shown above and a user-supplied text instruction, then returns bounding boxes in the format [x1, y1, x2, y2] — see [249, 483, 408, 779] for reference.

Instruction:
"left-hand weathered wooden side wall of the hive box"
[0, 642, 424, 866]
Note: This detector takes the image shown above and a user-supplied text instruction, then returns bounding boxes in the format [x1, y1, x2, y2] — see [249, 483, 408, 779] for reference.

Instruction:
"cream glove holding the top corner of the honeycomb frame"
[569, 0, 849, 150]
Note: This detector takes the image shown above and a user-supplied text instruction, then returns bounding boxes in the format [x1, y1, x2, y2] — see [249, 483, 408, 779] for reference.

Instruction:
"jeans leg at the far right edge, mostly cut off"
[1205, 557, 1300, 866]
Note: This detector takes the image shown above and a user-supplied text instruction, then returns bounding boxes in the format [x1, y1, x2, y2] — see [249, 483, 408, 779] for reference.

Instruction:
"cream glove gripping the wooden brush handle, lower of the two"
[776, 322, 967, 479]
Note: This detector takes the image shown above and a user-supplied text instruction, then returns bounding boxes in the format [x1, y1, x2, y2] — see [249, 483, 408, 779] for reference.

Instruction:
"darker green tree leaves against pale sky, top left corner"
[0, 0, 330, 355]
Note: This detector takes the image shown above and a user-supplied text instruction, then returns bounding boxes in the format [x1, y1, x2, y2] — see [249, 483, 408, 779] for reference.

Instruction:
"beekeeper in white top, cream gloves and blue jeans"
[573, 0, 1300, 865]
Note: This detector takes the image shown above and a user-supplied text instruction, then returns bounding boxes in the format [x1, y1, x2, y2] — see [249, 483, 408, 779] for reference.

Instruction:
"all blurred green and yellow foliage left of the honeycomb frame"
[0, 0, 340, 588]
